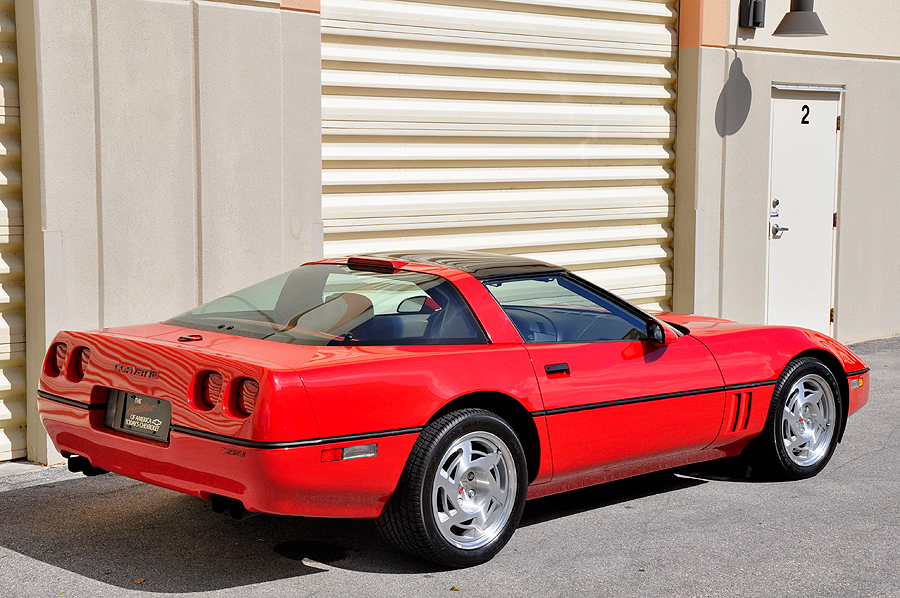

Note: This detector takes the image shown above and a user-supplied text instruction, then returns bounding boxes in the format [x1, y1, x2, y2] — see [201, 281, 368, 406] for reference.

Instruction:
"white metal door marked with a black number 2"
[767, 91, 841, 334]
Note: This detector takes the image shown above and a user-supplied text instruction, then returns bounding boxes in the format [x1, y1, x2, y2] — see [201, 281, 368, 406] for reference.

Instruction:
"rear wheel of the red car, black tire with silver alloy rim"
[376, 409, 528, 567]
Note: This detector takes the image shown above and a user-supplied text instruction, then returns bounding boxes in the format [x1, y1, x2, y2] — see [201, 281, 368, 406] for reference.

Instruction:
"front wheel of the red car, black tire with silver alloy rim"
[750, 357, 843, 480]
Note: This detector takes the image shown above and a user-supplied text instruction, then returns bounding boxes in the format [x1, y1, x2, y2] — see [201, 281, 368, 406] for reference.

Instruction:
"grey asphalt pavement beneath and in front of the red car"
[0, 338, 900, 598]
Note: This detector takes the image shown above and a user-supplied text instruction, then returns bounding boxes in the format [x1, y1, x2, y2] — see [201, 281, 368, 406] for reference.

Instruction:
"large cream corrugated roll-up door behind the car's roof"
[322, 0, 677, 308]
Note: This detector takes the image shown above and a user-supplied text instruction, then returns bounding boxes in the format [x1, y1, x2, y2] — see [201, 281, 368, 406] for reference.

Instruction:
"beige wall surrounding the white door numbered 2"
[674, 0, 900, 342]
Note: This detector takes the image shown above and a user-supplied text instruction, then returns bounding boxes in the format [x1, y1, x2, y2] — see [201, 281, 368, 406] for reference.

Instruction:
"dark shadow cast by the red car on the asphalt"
[0, 464, 768, 593]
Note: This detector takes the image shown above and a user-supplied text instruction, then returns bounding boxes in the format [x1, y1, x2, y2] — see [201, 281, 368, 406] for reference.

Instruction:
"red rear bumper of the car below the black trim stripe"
[38, 397, 418, 518]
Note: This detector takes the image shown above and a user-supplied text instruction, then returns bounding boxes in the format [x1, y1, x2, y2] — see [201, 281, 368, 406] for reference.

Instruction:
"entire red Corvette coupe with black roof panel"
[39, 252, 869, 567]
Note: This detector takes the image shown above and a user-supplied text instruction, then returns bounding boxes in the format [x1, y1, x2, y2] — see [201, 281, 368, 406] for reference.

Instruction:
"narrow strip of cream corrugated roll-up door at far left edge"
[0, 0, 25, 460]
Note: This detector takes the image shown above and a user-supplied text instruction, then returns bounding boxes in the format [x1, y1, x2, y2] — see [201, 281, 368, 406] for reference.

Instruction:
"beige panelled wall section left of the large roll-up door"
[16, 0, 322, 461]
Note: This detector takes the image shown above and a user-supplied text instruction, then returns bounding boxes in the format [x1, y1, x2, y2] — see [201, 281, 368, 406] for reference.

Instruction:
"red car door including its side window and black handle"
[486, 276, 725, 487]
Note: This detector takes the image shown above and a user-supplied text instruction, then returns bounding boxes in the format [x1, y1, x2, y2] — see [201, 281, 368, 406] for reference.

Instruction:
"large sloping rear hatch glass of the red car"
[165, 264, 487, 345]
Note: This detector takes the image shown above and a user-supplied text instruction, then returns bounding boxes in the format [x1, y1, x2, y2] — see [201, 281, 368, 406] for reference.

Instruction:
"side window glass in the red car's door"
[485, 276, 647, 343]
